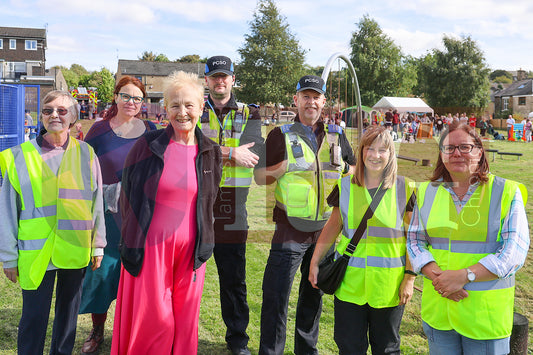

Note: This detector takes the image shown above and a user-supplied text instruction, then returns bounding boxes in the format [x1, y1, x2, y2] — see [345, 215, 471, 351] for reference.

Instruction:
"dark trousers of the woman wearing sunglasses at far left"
[17, 268, 86, 355]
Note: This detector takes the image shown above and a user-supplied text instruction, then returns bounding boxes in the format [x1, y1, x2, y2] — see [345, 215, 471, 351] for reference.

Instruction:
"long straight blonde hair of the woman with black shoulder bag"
[353, 126, 398, 189]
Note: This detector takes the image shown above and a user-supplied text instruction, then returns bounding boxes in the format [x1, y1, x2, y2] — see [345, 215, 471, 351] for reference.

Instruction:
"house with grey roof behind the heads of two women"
[116, 59, 205, 103]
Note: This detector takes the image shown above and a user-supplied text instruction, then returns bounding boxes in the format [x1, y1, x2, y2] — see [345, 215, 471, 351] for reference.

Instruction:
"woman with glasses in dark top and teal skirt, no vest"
[80, 76, 156, 354]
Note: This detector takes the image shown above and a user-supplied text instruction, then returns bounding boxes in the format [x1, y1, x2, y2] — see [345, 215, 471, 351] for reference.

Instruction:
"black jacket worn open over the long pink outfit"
[119, 125, 222, 276]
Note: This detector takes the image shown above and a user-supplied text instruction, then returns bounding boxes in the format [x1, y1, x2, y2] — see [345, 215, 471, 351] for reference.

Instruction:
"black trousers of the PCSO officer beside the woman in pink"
[213, 241, 249, 349]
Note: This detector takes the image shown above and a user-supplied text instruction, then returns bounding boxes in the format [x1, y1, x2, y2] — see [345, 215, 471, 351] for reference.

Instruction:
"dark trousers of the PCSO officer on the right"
[259, 224, 323, 355]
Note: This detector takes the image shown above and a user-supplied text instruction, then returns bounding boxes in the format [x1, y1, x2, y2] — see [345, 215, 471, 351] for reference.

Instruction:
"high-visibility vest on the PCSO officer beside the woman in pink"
[198, 104, 254, 187]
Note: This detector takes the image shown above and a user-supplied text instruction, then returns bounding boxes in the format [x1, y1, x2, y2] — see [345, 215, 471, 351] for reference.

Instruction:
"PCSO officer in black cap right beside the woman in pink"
[200, 56, 264, 355]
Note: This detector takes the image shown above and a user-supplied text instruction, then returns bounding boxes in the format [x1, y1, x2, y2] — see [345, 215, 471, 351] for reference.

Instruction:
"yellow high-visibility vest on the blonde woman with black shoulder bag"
[335, 176, 414, 308]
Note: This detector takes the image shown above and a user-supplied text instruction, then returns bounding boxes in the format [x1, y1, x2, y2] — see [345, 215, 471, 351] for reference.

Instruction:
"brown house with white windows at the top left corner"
[0, 27, 46, 83]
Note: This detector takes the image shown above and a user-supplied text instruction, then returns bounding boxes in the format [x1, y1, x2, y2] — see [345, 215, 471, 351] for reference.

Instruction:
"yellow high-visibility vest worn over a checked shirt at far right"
[418, 175, 527, 340]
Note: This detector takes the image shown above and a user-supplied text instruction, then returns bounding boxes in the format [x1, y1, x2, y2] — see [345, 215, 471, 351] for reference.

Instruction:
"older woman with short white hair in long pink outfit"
[111, 71, 222, 354]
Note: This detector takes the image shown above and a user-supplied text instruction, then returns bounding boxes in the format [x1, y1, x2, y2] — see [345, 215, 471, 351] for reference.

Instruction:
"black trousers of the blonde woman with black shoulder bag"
[334, 297, 404, 355]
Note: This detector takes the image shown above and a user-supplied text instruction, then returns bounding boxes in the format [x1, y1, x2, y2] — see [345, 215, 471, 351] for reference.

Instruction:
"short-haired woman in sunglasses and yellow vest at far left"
[0, 91, 106, 354]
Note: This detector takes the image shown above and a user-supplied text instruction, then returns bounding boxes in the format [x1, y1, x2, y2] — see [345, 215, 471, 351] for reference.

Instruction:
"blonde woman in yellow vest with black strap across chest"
[309, 126, 416, 354]
